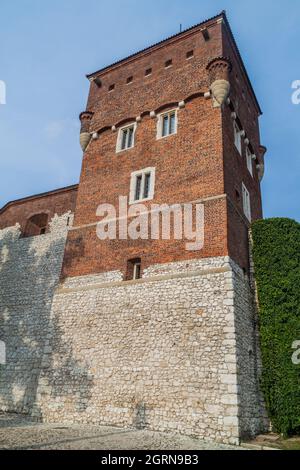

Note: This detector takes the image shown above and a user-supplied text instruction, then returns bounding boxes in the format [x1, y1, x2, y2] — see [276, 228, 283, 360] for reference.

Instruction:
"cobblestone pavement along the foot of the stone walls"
[0, 414, 239, 450]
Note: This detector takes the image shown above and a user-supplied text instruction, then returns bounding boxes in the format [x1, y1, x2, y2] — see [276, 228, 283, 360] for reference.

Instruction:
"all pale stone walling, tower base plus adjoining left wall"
[0, 226, 265, 444]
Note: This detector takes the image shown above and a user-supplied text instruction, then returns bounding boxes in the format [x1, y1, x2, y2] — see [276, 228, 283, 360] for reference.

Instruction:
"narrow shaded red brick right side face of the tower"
[223, 26, 262, 268]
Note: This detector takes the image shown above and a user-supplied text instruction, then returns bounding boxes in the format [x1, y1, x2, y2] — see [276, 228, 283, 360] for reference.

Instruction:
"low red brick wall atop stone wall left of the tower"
[0, 186, 77, 232]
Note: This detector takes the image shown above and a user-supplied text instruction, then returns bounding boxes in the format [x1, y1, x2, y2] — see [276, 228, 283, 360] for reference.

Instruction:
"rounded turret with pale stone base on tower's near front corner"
[206, 57, 232, 106]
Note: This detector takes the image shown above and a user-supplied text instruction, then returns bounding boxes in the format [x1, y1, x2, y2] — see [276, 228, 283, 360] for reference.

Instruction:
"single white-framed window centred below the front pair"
[129, 168, 155, 204]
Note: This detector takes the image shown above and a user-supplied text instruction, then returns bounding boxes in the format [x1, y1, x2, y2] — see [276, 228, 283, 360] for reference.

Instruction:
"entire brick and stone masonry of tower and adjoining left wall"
[0, 14, 267, 444]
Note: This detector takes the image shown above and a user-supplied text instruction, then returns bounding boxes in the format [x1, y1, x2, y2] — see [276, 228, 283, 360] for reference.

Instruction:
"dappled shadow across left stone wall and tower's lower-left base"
[0, 222, 93, 418]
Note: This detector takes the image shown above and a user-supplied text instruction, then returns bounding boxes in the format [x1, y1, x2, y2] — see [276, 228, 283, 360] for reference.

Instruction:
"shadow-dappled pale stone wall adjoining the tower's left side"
[0, 212, 72, 413]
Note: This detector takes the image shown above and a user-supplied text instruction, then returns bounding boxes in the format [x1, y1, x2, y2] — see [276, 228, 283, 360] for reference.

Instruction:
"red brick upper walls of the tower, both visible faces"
[62, 14, 262, 277]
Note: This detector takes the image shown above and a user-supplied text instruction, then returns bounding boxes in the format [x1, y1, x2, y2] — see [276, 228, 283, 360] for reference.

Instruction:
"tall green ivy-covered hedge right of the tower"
[252, 219, 300, 436]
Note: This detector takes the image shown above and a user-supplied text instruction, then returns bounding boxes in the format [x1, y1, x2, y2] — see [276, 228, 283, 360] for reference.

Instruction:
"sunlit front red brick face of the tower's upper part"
[63, 20, 232, 276]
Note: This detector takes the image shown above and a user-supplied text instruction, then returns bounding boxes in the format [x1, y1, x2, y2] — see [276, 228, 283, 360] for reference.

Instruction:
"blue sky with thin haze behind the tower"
[0, 0, 300, 220]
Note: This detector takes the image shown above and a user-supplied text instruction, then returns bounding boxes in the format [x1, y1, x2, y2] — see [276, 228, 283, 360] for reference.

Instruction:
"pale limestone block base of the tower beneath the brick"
[33, 257, 262, 444]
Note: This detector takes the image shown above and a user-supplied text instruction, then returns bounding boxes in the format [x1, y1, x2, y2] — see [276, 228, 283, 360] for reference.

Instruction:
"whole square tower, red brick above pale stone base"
[0, 13, 265, 443]
